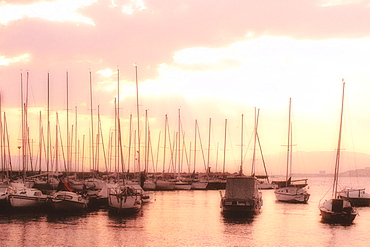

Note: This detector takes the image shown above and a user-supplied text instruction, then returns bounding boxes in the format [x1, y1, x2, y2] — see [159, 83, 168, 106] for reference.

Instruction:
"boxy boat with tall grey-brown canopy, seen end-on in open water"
[221, 176, 263, 214]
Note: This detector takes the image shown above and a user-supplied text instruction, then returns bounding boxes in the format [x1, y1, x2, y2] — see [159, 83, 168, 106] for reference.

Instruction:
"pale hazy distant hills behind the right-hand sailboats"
[265, 151, 370, 176]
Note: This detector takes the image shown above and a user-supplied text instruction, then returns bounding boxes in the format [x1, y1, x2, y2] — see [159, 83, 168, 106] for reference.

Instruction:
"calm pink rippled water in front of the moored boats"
[0, 178, 370, 246]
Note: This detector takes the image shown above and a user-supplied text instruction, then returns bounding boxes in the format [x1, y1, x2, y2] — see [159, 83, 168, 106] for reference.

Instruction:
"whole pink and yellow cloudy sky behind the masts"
[0, 0, 370, 175]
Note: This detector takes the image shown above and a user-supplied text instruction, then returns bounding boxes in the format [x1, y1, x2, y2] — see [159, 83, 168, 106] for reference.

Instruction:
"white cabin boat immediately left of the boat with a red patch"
[9, 183, 47, 208]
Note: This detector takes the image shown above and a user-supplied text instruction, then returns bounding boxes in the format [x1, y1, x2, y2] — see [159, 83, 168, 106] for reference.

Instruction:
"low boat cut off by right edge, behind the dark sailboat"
[339, 188, 370, 207]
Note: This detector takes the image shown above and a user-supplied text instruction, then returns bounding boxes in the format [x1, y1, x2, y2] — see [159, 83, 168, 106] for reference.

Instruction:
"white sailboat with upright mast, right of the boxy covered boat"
[274, 99, 310, 203]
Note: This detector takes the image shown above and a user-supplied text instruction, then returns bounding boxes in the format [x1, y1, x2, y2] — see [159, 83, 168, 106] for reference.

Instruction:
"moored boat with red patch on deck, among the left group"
[50, 181, 88, 212]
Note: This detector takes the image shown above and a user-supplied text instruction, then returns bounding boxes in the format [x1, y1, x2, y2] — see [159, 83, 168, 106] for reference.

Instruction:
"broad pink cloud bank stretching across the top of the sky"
[0, 0, 370, 79]
